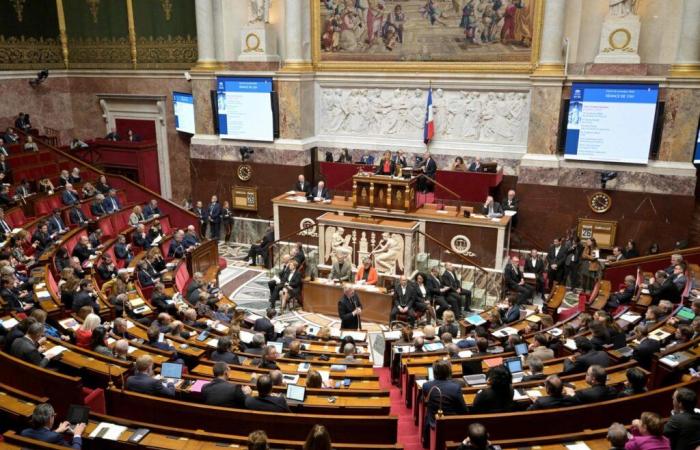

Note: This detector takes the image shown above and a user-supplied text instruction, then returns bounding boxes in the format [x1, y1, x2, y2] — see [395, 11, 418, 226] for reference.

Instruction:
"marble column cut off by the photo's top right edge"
[671, 0, 700, 78]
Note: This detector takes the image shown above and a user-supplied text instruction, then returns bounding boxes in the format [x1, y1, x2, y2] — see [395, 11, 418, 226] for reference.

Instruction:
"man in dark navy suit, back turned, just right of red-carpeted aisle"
[422, 360, 467, 443]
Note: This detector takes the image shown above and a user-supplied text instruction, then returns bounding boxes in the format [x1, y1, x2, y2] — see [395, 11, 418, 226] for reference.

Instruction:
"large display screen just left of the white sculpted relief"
[216, 77, 274, 142]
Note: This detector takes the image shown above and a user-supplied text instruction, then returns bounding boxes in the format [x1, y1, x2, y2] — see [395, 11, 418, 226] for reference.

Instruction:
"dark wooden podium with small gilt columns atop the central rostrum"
[352, 173, 418, 212]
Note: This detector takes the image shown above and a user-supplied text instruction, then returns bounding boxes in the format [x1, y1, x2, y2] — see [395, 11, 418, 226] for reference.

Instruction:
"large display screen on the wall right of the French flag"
[564, 83, 659, 164]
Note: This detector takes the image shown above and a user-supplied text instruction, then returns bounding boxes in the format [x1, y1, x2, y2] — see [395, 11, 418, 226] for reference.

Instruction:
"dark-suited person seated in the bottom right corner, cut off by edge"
[664, 388, 700, 450]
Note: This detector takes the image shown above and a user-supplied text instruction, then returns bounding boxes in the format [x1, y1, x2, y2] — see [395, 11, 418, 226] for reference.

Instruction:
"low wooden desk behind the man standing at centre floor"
[303, 281, 392, 324]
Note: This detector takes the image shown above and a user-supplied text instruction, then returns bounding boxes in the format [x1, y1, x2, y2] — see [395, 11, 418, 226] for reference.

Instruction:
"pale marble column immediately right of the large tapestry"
[535, 0, 566, 75]
